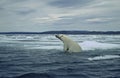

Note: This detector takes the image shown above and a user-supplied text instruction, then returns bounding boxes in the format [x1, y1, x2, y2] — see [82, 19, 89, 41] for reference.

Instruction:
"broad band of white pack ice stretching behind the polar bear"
[0, 34, 120, 51]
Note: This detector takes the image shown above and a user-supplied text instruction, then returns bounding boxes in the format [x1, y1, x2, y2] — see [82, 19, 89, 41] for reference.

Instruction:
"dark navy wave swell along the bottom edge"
[0, 72, 88, 78]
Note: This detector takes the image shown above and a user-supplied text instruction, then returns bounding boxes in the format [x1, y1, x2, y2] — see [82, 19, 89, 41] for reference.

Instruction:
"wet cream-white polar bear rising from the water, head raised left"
[55, 34, 82, 52]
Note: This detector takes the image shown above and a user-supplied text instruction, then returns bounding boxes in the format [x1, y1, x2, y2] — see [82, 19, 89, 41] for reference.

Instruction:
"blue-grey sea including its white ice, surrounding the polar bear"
[0, 34, 120, 78]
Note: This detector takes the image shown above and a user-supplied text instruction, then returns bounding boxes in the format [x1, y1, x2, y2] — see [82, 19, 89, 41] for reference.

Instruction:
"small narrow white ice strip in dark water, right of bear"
[88, 55, 120, 61]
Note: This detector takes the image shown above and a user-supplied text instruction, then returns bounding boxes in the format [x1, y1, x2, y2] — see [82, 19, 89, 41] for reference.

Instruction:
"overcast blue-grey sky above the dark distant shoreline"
[0, 0, 120, 32]
